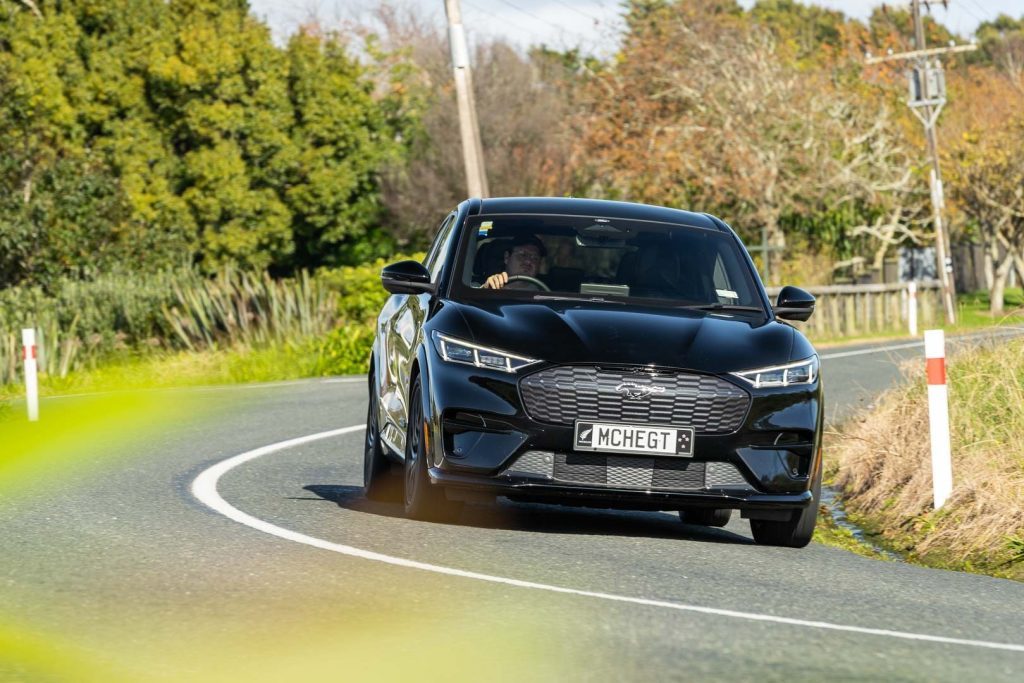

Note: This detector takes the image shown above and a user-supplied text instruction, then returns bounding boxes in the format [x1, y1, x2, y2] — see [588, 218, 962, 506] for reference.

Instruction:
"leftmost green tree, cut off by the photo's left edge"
[0, 0, 152, 287]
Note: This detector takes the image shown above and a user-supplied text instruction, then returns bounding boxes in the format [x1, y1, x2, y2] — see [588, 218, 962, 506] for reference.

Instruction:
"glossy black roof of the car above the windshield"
[478, 197, 726, 231]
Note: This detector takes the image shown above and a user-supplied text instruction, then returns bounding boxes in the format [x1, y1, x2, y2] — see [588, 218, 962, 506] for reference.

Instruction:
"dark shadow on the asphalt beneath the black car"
[304, 484, 754, 545]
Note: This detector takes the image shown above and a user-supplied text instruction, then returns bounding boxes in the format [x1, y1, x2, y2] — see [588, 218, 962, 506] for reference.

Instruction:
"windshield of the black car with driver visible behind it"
[454, 215, 764, 313]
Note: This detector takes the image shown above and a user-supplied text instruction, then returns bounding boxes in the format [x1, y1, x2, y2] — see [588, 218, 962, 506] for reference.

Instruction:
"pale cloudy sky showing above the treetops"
[250, 0, 1024, 54]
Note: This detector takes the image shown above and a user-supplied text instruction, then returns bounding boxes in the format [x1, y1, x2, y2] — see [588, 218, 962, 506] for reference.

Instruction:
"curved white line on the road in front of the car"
[191, 425, 1024, 652]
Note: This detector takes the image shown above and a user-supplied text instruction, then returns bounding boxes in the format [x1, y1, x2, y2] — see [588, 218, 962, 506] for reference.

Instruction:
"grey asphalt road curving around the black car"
[0, 327, 1024, 681]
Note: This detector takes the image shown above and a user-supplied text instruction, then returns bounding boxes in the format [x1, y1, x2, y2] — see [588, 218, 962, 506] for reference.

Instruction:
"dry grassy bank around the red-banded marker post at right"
[826, 341, 1024, 581]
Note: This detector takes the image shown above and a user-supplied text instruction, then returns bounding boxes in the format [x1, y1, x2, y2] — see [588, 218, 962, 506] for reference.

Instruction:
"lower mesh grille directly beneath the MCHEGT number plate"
[554, 453, 705, 490]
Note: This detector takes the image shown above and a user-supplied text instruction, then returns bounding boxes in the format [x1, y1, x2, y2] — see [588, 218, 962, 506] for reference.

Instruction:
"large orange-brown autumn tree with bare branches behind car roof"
[575, 2, 910, 282]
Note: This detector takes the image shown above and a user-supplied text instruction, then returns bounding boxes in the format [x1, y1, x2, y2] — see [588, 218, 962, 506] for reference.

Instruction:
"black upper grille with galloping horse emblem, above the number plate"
[519, 366, 751, 433]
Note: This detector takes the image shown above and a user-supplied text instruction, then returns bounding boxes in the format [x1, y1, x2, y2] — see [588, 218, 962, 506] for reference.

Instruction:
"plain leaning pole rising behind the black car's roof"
[444, 0, 489, 197]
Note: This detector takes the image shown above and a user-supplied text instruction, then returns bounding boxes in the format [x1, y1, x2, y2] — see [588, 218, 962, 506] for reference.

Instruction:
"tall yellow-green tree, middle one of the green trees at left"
[146, 0, 294, 270]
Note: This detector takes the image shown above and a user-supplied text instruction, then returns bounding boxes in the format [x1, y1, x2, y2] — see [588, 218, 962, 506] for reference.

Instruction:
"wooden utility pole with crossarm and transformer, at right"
[866, 0, 977, 325]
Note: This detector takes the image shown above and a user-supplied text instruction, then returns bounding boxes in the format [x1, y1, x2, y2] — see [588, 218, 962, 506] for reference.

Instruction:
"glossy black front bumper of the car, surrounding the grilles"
[428, 356, 822, 510]
